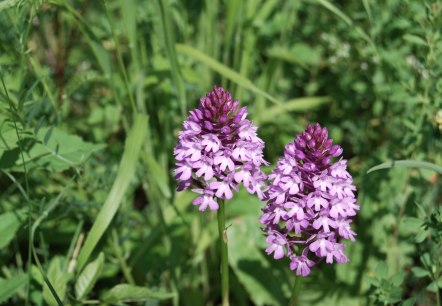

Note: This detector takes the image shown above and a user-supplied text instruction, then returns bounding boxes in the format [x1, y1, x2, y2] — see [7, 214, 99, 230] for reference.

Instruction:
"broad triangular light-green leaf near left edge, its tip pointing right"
[16, 127, 103, 172]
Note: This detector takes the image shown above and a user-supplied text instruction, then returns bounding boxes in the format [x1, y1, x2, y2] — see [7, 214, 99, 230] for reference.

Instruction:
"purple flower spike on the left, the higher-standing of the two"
[174, 86, 268, 210]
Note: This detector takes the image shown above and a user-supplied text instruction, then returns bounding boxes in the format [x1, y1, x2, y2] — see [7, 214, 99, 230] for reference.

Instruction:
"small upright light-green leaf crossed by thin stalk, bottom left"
[43, 256, 68, 306]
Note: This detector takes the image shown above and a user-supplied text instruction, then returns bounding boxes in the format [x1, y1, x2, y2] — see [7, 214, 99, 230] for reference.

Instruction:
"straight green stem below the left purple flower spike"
[218, 200, 229, 306]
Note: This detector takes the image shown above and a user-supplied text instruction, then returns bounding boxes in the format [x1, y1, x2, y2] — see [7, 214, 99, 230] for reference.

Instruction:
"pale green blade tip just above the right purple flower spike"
[258, 97, 330, 123]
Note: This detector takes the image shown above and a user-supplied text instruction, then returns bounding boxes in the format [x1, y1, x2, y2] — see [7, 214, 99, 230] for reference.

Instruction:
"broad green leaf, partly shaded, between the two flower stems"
[227, 215, 288, 305]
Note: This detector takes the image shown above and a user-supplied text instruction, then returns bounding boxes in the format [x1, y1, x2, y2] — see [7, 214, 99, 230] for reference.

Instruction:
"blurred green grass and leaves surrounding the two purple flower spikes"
[0, 0, 442, 305]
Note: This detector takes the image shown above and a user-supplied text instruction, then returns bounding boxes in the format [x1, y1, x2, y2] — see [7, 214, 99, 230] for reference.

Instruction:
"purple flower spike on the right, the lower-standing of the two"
[258, 124, 359, 276]
